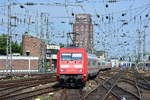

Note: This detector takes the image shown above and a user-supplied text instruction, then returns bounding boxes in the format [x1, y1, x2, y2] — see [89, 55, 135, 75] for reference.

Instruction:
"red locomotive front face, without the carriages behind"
[57, 48, 86, 81]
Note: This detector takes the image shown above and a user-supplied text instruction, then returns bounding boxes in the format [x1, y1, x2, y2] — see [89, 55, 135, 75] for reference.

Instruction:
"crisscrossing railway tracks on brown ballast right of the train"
[54, 70, 150, 100]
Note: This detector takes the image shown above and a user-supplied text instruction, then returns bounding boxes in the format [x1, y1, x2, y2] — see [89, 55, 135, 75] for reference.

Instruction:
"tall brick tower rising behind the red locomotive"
[73, 14, 93, 51]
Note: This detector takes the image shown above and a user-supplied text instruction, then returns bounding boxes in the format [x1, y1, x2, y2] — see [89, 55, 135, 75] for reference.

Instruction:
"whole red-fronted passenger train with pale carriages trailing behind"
[57, 47, 111, 84]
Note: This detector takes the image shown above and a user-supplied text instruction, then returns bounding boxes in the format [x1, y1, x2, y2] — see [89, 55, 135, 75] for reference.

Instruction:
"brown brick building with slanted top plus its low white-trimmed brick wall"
[0, 34, 46, 72]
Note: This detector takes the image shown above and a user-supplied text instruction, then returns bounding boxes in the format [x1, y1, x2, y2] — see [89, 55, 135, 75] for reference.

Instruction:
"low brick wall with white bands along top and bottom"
[0, 56, 38, 72]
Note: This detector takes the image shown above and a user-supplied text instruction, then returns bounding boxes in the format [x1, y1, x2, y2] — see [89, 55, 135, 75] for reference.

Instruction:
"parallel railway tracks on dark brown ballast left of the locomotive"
[0, 74, 57, 100]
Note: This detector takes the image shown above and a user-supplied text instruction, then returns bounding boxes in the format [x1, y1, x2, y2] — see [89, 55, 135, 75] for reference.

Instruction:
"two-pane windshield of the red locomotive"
[61, 53, 82, 60]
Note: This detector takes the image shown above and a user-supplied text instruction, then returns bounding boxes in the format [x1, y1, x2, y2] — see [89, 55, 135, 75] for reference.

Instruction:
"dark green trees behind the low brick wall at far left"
[0, 34, 23, 55]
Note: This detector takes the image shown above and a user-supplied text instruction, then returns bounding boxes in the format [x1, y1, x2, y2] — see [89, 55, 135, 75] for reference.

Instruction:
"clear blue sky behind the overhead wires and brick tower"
[0, 0, 150, 57]
